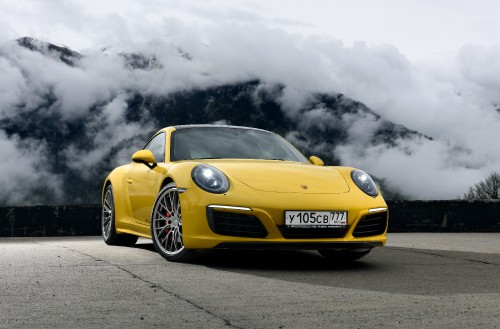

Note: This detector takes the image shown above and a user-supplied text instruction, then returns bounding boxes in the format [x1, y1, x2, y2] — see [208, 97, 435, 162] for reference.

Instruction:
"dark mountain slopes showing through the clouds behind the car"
[0, 38, 429, 204]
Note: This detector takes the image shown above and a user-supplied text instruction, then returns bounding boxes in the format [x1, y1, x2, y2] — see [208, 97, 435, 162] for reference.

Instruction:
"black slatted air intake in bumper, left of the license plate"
[207, 208, 268, 238]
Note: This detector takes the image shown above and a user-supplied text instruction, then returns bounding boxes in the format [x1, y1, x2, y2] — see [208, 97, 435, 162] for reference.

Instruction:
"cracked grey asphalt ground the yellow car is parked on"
[0, 234, 500, 328]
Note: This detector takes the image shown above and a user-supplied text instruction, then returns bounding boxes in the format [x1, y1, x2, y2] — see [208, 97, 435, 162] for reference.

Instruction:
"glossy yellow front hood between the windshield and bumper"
[211, 161, 349, 194]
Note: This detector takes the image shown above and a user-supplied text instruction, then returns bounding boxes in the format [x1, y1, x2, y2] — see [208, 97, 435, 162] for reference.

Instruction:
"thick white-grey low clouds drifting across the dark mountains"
[0, 1, 500, 203]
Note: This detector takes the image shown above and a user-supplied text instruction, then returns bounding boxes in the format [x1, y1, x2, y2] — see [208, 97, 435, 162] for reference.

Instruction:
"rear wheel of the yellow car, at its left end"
[101, 184, 138, 246]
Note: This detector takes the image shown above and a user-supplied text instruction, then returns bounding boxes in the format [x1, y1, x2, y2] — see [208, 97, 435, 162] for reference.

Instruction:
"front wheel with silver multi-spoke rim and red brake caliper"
[151, 183, 197, 262]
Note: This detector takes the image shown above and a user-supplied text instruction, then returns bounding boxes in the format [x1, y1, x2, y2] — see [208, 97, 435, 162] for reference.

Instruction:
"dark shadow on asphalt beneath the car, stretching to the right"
[131, 243, 500, 295]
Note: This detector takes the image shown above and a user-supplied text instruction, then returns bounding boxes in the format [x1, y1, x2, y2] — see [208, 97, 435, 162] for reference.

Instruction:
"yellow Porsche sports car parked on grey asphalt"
[102, 125, 388, 261]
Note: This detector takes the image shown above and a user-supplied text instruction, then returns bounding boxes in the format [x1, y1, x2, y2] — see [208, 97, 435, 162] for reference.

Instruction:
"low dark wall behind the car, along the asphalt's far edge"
[0, 200, 500, 237]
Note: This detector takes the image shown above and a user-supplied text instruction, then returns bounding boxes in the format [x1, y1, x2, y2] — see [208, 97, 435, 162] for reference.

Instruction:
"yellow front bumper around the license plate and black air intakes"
[180, 185, 387, 249]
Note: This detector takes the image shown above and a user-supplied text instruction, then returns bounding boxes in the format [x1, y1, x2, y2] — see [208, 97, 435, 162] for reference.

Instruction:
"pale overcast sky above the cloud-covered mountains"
[0, 0, 500, 60]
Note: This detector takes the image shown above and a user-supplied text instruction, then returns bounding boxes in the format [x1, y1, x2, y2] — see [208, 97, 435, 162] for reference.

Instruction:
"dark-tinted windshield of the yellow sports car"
[170, 126, 308, 162]
